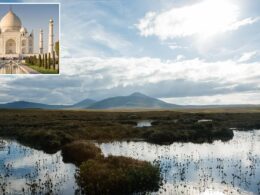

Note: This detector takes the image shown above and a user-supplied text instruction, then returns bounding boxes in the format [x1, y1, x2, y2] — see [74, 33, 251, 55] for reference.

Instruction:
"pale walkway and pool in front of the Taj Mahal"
[0, 60, 40, 74]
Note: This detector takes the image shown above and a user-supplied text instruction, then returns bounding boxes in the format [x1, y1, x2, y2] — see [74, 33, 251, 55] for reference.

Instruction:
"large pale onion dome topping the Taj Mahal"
[0, 10, 22, 32]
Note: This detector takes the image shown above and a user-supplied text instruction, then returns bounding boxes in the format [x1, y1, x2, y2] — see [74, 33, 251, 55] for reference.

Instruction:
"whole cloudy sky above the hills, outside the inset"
[0, 0, 260, 105]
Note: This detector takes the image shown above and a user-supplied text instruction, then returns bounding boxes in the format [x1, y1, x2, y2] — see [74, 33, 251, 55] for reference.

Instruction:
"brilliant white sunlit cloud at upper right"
[136, 0, 259, 40]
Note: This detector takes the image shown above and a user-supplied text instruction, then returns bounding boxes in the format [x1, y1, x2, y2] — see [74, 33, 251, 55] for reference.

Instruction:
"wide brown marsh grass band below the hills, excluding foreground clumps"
[0, 110, 260, 153]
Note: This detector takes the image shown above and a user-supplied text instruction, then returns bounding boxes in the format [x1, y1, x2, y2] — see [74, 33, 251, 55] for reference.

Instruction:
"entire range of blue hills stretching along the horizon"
[0, 92, 260, 110]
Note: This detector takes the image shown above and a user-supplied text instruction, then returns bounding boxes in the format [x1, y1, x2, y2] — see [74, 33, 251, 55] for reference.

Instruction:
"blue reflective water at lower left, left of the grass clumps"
[0, 139, 77, 195]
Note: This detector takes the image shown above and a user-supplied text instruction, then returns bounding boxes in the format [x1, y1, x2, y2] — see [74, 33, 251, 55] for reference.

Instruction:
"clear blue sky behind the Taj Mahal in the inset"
[0, 1, 59, 53]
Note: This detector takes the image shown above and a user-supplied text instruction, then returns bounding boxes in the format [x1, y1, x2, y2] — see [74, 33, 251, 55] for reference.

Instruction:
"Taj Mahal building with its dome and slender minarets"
[0, 8, 54, 58]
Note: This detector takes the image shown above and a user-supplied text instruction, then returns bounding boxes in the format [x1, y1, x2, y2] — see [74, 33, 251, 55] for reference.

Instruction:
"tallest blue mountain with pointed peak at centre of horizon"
[87, 93, 180, 109]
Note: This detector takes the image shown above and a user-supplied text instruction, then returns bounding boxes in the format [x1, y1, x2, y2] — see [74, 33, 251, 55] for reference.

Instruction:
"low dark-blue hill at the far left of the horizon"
[0, 101, 64, 109]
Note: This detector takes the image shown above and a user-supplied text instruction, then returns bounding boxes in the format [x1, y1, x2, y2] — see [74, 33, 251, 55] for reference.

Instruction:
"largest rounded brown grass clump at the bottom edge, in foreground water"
[76, 156, 161, 195]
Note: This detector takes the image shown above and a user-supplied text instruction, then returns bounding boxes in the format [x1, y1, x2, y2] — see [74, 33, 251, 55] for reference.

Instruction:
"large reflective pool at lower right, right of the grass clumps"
[100, 130, 260, 195]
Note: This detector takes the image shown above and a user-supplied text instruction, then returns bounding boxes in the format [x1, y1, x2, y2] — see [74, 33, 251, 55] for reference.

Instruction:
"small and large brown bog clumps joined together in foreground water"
[62, 140, 161, 195]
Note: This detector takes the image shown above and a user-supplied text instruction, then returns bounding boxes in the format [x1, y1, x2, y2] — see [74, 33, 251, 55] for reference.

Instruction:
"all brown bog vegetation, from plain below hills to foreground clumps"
[0, 109, 260, 195]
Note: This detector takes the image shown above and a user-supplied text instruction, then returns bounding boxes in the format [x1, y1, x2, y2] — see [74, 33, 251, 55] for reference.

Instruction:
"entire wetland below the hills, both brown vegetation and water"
[0, 110, 260, 195]
